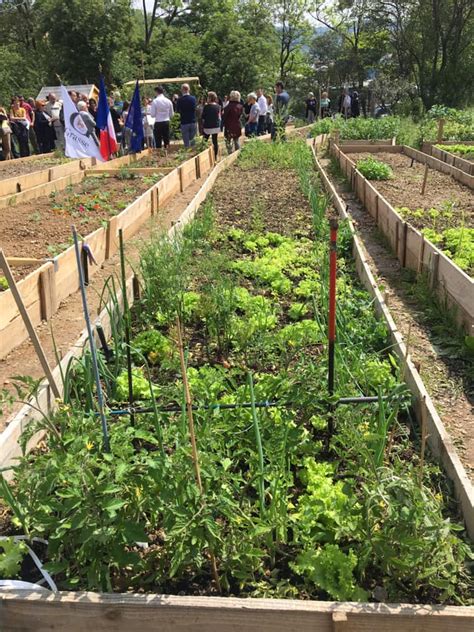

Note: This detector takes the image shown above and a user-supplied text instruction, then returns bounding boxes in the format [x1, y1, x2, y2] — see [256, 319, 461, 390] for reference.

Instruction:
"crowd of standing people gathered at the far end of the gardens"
[0, 81, 360, 160]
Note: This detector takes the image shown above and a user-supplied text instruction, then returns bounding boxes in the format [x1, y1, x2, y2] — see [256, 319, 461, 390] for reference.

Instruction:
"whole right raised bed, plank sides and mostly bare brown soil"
[331, 143, 474, 335]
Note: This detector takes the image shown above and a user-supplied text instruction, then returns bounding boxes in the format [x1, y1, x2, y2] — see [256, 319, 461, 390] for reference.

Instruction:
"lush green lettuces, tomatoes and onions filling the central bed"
[3, 143, 469, 602]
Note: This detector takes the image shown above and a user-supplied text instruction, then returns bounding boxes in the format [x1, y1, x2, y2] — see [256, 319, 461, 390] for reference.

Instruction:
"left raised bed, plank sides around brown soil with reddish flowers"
[0, 149, 211, 358]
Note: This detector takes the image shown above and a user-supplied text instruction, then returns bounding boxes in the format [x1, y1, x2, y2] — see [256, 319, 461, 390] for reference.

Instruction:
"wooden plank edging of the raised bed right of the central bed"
[331, 143, 474, 336]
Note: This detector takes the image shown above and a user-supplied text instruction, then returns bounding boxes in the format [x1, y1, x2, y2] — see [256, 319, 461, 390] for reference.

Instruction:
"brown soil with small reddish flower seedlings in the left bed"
[0, 176, 159, 278]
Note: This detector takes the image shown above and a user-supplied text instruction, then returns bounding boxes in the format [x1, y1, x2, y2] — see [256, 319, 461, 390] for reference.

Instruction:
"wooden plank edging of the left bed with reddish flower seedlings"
[0, 149, 211, 359]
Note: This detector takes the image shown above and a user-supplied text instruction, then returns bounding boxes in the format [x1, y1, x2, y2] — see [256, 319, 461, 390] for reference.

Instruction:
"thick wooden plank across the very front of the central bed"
[0, 591, 474, 632]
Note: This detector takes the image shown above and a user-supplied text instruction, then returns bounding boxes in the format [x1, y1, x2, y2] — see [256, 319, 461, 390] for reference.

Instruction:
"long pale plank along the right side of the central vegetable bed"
[314, 138, 474, 539]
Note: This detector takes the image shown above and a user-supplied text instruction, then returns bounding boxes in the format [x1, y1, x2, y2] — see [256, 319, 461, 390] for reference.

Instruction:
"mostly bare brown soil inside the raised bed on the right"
[349, 152, 474, 231]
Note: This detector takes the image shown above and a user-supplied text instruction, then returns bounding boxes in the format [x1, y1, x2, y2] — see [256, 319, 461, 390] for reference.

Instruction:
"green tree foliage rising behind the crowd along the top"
[0, 0, 474, 113]
